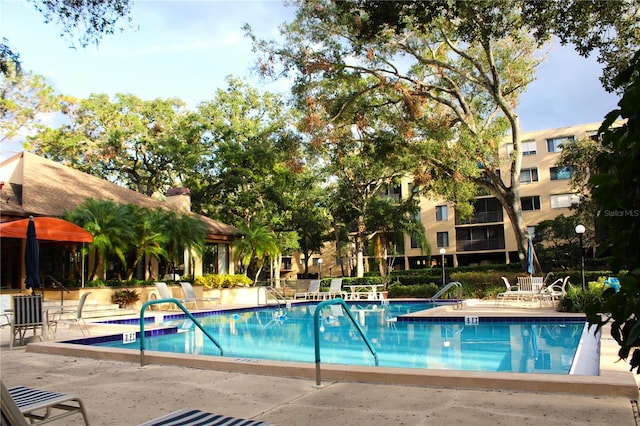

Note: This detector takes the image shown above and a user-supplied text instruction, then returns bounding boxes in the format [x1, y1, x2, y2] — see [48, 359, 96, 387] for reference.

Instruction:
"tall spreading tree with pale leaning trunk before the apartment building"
[250, 1, 540, 270]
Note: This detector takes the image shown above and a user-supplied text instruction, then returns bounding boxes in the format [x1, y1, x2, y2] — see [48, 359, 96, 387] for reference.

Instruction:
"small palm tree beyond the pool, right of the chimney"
[233, 222, 280, 283]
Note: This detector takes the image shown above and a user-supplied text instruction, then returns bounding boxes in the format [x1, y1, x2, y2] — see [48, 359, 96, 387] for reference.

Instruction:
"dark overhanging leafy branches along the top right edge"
[336, 0, 640, 91]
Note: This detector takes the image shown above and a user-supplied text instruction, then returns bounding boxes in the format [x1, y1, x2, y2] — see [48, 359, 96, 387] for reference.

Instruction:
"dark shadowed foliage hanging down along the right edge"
[587, 50, 640, 374]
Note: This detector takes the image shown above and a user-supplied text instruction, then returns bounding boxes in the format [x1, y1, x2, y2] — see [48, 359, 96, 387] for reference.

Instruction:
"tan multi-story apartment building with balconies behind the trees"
[285, 123, 620, 276]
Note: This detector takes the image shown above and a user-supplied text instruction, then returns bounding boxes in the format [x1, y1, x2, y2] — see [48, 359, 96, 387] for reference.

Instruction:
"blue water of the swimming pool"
[81, 303, 585, 374]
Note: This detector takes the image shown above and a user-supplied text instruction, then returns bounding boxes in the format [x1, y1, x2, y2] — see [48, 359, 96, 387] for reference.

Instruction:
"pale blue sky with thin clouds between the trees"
[0, 0, 618, 158]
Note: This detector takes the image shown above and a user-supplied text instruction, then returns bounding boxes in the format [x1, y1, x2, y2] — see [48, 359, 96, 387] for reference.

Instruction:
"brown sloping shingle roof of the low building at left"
[0, 152, 237, 240]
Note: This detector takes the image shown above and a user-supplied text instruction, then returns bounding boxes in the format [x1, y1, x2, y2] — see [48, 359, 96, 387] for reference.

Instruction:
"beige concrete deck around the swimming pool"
[0, 303, 638, 426]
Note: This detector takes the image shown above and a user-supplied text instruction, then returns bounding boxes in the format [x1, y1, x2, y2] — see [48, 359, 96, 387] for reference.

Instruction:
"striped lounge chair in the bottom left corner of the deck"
[0, 381, 89, 426]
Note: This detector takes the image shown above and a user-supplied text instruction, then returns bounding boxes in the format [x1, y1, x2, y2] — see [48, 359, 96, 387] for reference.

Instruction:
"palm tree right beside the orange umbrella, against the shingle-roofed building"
[65, 198, 134, 280]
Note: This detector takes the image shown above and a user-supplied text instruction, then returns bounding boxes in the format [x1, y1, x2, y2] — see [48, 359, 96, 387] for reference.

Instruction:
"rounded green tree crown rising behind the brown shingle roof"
[32, 94, 196, 196]
